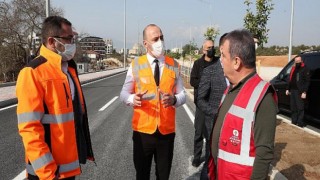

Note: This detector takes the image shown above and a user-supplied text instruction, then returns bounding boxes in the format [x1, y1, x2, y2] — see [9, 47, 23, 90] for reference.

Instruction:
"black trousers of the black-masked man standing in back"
[193, 107, 205, 161]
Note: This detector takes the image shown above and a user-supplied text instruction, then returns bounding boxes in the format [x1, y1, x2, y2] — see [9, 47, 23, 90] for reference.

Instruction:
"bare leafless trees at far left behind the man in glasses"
[0, 0, 62, 81]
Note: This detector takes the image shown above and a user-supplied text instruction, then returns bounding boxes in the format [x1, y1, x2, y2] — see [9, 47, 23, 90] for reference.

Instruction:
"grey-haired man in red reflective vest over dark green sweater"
[208, 30, 277, 180]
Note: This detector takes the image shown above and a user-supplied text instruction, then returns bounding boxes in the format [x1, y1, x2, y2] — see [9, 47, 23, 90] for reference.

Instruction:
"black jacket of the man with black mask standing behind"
[190, 55, 216, 105]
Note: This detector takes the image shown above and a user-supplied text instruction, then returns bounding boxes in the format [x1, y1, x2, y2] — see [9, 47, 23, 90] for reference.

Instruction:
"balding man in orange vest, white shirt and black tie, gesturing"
[120, 24, 186, 180]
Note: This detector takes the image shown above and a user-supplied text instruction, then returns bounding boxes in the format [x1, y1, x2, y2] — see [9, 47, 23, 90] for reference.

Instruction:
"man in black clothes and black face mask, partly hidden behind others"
[190, 40, 215, 167]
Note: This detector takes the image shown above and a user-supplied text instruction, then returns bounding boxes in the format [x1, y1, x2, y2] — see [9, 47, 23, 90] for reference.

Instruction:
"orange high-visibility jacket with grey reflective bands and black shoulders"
[16, 45, 94, 179]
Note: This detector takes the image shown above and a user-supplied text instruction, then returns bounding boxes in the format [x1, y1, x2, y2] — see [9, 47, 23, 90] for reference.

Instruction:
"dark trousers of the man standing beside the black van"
[290, 89, 304, 125]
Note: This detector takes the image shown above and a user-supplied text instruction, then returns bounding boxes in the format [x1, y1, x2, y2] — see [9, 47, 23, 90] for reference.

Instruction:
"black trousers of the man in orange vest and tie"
[132, 130, 175, 180]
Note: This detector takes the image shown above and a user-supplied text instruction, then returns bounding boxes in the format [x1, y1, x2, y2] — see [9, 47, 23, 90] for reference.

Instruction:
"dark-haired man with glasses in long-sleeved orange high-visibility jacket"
[16, 16, 94, 179]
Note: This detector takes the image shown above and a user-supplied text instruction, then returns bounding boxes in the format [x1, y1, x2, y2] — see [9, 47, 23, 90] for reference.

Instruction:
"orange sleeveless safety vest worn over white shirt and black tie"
[132, 55, 179, 135]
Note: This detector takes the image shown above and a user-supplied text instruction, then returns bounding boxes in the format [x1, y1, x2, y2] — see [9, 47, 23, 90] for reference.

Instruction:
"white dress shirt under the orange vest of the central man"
[120, 53, 186, 107]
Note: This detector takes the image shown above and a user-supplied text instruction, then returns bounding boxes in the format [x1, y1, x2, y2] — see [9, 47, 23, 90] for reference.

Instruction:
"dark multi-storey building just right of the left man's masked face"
[79, 36, 106, 59]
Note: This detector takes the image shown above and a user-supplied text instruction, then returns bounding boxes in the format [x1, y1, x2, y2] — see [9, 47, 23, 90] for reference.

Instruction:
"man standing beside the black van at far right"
[286, 56, 310, 127]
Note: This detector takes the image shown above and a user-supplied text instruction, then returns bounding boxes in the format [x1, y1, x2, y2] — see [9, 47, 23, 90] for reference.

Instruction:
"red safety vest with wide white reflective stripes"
[208, 74, 277, 180]
